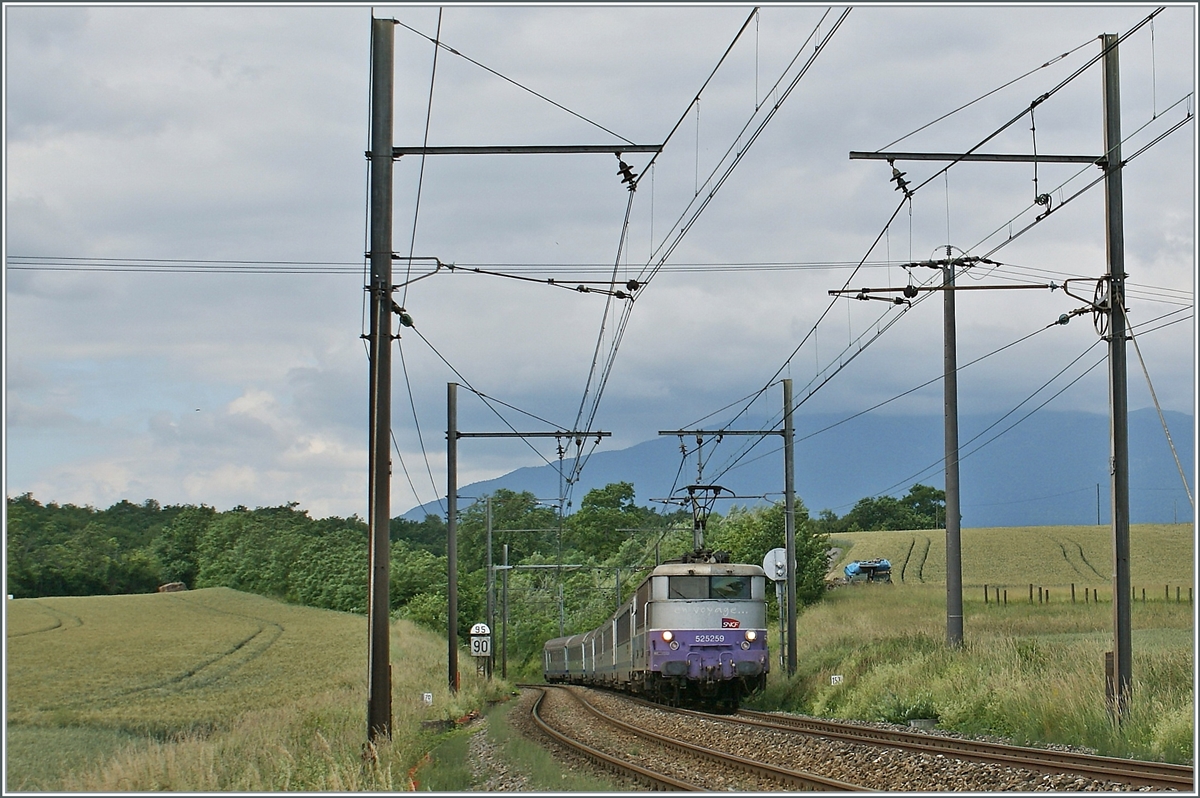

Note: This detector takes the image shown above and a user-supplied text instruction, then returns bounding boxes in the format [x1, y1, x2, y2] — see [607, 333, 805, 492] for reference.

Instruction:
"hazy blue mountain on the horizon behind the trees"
[404, 409, 1195, 527]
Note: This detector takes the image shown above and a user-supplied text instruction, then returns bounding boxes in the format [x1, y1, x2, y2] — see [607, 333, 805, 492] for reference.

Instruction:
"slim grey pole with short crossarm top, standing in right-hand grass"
[942, 250, 962, 648]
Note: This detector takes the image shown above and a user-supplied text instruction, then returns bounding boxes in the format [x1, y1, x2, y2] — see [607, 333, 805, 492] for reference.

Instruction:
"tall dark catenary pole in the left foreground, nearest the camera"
[367, 19, 396, 742]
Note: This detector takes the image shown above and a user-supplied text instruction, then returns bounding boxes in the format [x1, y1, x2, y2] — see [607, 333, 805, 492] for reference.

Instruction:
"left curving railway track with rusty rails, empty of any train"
[533, 685, 866, 791]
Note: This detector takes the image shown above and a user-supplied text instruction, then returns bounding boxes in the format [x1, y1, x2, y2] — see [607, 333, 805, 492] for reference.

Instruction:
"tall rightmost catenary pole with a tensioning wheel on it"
[1100, 34, 1133, 719]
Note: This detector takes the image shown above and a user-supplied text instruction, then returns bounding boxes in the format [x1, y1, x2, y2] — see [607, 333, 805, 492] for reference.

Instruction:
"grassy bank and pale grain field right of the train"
[755, 524, 1194, 762]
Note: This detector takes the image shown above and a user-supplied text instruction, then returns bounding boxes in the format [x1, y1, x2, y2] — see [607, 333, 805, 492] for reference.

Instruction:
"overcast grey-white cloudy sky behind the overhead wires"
[4, 4, 1196, 517]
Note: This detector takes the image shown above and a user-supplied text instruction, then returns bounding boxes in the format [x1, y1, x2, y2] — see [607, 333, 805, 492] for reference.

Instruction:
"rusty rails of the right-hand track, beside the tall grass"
[729, 709, 1194, 791]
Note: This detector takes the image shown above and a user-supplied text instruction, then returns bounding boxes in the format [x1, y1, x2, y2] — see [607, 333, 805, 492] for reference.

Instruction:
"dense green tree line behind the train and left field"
[7, 482, 940, 672]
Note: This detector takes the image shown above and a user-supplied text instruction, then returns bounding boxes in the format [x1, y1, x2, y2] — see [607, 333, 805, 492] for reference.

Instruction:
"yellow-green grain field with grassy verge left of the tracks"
[6, 588, 520, 792]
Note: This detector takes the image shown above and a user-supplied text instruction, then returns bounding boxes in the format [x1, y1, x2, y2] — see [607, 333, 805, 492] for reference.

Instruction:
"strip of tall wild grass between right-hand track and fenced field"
[756, 586, 1194, 762]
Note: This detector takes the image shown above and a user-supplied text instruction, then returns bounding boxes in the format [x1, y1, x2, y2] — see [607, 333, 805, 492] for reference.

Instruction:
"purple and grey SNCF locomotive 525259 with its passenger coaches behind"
[542, 562, 770, 712]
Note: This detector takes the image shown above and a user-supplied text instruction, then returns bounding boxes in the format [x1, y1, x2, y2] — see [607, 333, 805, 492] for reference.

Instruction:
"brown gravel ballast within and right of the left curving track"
[566, 690, 1150, 792]
